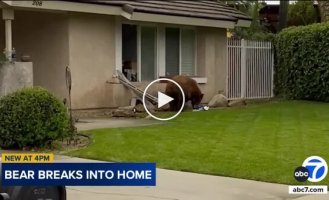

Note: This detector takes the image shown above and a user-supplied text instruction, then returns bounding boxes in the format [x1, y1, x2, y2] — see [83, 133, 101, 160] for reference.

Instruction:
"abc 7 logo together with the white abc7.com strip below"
[289, 156, 328, 194]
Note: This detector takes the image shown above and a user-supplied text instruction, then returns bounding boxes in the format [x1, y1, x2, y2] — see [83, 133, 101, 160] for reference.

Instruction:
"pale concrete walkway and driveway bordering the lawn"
[65, 119, 329, 200]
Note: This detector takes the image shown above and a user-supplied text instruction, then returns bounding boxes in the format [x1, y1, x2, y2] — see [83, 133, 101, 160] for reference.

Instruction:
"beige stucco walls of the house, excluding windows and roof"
[0, 11, 227, 109]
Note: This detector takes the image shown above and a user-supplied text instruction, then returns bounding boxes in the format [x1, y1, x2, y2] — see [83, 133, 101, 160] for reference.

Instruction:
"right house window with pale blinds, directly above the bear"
[165, 28, 196, 76]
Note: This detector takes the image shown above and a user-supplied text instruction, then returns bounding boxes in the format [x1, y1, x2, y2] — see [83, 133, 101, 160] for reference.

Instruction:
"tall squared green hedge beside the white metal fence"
[275, 23, 329, 101]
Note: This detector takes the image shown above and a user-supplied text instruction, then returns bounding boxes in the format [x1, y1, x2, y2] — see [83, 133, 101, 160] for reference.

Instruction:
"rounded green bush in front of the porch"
[0, 87, 70, 148]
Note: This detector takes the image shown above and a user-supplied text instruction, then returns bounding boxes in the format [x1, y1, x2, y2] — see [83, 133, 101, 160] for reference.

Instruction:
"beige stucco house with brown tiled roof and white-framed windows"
[0, 1, 250, 110]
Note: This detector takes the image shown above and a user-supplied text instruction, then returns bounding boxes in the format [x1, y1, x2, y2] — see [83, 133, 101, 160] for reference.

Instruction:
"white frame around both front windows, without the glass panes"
[115, 17, 198, 82]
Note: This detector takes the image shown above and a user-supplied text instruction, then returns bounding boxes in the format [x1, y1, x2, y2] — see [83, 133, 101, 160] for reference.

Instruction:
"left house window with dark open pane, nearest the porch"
[122, 24, 157, 82]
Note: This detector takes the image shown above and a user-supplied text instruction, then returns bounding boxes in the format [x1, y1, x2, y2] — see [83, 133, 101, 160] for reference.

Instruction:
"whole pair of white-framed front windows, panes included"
[122, 24, 196, 82]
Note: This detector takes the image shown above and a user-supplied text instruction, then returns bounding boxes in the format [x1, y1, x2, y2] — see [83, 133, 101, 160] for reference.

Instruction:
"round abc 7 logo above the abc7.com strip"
[294, 156, 328, 182]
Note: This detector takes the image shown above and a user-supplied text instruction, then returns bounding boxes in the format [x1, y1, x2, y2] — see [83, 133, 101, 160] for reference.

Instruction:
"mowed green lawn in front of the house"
[69, 101, 329, 185]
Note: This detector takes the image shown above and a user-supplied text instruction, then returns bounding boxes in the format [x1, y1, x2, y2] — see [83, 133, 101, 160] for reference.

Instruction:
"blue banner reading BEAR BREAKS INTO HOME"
[1, 163, 156, 186]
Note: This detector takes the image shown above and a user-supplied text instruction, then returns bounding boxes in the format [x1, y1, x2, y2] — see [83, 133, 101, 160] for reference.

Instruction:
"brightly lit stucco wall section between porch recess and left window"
[69, 14, 130, 109]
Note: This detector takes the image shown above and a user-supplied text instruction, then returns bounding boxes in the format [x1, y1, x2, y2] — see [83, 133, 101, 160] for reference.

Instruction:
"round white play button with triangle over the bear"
[143, 78, 185, 121]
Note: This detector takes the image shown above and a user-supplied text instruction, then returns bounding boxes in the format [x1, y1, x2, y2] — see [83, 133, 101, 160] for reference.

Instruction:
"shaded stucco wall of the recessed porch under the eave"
[0, 10, 68, 98]
